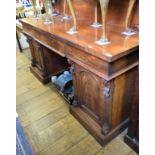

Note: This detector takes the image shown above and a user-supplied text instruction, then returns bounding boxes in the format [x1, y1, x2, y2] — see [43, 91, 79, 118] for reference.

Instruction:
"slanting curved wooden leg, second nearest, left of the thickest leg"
[67, 0, 78, 35]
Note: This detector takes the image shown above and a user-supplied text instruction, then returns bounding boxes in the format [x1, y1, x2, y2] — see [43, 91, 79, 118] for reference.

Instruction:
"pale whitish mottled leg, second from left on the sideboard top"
[44, 0, 53, 24]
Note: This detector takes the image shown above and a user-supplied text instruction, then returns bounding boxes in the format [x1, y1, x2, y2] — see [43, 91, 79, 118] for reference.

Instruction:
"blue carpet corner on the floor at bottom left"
[16, 118, 34, 155]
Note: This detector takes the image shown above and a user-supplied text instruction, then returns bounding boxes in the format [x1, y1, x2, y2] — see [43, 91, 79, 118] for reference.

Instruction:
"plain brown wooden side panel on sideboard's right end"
[111, 67, 137, 128]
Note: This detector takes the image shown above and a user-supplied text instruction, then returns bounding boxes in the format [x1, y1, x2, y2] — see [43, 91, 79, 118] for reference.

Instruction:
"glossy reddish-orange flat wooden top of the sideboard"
[20, 16, 139, 62]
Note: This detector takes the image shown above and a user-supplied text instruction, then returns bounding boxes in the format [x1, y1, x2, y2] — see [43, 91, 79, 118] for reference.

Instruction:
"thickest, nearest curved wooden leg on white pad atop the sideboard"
[95, 0, 110, 45]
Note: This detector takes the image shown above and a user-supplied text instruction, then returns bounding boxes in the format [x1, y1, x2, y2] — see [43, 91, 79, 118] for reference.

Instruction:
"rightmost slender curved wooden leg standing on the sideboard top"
[122, 0, 136, 36]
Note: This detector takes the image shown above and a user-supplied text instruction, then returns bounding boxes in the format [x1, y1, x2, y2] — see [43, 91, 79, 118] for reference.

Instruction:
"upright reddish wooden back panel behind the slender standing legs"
[56, 0, 139, 27]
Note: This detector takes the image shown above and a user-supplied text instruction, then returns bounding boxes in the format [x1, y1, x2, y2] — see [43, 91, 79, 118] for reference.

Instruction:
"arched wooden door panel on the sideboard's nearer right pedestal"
[75, 65, 104, 125]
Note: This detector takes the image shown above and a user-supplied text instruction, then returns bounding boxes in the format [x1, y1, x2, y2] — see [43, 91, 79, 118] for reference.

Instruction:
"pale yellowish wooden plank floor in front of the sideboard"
[16, 49, 136, 155]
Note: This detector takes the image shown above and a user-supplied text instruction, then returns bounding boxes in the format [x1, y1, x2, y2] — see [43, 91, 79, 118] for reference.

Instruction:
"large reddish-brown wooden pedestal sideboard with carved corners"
[20, 0, 139, 145]
